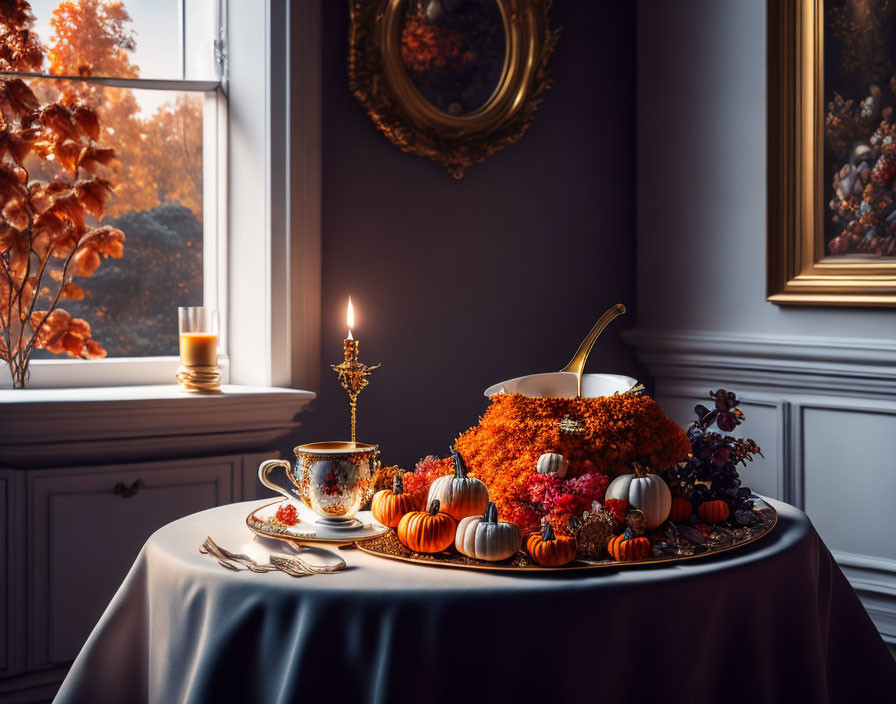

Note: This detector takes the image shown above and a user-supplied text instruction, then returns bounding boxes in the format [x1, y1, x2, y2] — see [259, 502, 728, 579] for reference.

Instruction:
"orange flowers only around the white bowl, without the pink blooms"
[455, 394, 691, 531]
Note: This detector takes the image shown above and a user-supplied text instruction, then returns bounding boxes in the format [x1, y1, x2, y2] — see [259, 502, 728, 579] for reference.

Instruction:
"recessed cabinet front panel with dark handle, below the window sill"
[28, 456, 242, 667]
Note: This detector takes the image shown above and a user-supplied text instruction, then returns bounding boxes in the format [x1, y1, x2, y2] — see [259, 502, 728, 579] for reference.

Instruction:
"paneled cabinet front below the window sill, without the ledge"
[0, 451, 288, 702]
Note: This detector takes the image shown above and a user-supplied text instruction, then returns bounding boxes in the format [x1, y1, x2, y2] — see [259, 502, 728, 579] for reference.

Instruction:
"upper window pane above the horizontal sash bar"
[16, 0, 218, 80]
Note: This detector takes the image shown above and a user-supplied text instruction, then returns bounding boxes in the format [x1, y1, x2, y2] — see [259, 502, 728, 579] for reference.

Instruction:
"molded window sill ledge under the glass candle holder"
[0, 385, 315, 469]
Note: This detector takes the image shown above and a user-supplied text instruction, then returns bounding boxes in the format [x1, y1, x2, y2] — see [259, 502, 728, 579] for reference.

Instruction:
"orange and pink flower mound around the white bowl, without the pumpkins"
[405, 393, 691, 534]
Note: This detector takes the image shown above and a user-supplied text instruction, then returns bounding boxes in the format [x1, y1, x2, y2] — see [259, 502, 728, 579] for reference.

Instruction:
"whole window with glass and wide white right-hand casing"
[0, 0, 321, 388]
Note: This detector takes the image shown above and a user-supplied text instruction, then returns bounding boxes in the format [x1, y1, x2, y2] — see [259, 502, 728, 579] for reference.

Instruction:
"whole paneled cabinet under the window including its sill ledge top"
[0, 386, 314, 703]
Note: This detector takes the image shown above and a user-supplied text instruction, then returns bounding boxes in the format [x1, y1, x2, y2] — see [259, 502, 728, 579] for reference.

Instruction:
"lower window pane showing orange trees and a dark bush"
[26, 79, 204, 358]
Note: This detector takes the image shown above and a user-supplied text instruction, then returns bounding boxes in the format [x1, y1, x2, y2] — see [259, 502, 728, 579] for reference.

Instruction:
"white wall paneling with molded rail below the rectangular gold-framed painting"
[626, 330, 896, 642]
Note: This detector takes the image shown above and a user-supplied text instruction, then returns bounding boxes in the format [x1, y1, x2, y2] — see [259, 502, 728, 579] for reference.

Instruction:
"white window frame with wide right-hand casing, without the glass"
[0, 0, 320, 390]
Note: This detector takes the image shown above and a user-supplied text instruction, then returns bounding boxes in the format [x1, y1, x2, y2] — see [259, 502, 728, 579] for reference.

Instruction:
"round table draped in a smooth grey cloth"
[56, 500, 896, 704]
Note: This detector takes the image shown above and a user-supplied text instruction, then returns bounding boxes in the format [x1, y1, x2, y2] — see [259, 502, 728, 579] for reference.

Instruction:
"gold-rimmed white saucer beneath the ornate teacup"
[246, 499, 389, 545]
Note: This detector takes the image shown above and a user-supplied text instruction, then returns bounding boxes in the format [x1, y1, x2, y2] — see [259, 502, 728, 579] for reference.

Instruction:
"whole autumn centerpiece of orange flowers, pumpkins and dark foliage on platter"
[360, 372, 775, 569]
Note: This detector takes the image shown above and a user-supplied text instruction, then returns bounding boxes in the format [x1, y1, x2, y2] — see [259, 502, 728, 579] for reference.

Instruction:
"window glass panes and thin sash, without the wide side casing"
[0, 0, 227, 386]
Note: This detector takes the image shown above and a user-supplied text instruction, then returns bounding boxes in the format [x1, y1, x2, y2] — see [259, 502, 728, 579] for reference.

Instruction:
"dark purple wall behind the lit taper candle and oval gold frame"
[296, 1, 643, 467]
